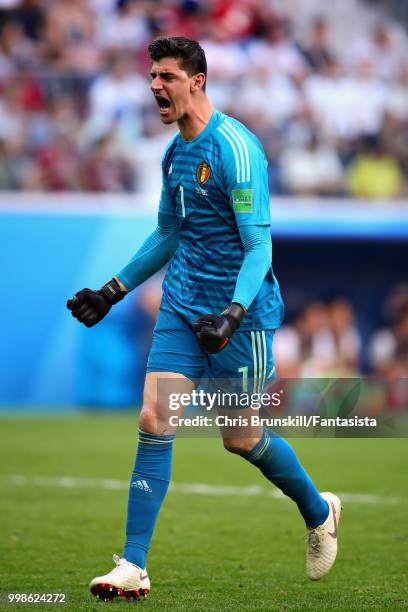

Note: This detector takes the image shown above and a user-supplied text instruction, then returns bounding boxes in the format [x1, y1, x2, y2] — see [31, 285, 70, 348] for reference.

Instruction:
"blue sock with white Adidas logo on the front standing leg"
[123, 431, 174, 569]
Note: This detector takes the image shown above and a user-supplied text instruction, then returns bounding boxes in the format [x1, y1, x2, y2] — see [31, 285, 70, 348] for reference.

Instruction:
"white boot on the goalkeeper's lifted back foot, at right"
[306, 493, 341, 580]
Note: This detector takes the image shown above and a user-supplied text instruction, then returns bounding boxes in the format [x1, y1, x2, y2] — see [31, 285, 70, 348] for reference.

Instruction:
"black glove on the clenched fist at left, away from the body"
[67, 278, 126, 327]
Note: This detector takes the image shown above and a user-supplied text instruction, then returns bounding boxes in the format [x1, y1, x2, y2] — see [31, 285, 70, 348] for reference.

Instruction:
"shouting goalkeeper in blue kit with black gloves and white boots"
[67, 37, 341, 599]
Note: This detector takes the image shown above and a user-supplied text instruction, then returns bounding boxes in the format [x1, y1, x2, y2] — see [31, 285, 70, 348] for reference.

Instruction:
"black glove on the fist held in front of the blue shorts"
[193, 302, 245, 353]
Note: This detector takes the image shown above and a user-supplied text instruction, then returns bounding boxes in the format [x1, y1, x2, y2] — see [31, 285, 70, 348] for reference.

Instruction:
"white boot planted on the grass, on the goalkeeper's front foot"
[89, 555, 150, 601]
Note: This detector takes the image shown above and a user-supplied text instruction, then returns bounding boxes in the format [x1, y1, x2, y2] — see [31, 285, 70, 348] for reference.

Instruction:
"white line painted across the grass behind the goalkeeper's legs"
[8, 476, 404, 505]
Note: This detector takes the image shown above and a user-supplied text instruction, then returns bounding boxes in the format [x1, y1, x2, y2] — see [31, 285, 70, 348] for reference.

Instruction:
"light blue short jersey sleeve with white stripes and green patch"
[218, 120, 271, 226]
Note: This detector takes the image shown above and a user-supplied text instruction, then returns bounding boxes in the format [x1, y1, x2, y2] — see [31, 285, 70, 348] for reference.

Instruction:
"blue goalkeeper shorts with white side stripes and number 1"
[147, 309, 275, 393]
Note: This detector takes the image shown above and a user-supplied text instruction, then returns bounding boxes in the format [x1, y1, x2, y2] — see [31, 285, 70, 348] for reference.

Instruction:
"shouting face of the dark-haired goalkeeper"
[150, 57, 204, 124]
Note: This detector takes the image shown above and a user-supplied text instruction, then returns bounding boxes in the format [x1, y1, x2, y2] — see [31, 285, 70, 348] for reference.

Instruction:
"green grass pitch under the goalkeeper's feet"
[0, 414, 408, 611]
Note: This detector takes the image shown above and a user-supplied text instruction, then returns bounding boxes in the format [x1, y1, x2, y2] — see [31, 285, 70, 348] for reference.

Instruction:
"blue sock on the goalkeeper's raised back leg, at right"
[242, 428, 329, 528]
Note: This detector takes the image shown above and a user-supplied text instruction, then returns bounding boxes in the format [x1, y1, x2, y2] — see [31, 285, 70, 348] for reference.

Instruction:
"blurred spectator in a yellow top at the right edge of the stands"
[347, 136, 404, 199]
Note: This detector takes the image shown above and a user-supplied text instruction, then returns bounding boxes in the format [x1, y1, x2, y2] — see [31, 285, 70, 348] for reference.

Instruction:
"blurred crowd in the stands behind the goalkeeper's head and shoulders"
[0, 0, 408, 196]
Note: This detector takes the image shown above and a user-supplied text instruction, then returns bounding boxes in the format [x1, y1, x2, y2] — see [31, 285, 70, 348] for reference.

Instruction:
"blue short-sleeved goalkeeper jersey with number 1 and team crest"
[160, 111, 284, 329]
